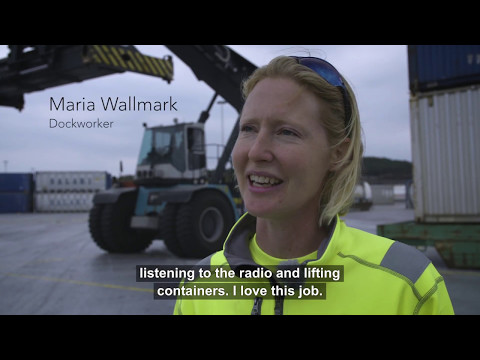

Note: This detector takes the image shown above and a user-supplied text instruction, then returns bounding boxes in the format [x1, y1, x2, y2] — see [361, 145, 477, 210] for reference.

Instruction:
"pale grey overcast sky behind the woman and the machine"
[0, 45, 411, 175]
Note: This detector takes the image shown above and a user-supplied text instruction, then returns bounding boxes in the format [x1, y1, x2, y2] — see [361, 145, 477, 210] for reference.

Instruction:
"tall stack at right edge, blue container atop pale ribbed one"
[408, 45, 480, 223]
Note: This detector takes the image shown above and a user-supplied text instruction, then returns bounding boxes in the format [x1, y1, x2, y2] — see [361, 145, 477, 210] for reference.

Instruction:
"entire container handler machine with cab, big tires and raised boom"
[0, 45, 256, 258]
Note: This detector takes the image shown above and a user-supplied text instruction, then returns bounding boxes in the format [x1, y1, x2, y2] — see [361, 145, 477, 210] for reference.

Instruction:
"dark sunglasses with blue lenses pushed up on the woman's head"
[290, 56, 352, 128]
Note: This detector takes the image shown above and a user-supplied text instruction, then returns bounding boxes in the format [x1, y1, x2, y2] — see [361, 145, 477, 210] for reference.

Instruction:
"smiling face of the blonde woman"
[232, 78, 331, 219]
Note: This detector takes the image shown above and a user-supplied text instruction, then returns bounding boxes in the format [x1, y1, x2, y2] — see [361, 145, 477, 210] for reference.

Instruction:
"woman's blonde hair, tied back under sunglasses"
[242, 56, 363, 226]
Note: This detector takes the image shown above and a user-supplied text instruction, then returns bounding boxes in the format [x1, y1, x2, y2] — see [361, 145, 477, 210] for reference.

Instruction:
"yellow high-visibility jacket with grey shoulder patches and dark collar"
[174, 213, 454, 315]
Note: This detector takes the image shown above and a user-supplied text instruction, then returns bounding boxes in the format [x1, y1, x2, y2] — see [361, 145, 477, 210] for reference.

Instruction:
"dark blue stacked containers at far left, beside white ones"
[0, 173, 33, 213]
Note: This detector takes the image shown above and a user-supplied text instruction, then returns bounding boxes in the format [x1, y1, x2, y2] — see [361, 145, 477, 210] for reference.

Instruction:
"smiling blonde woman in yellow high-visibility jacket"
[174, 56, 453, 314]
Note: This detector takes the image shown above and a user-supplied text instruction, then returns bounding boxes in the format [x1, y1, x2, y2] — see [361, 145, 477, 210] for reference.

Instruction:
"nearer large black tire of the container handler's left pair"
[97, 192, 155, 253]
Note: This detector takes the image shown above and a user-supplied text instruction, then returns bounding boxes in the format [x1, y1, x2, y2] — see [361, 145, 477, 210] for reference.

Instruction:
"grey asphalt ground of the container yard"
[0, 204, 480, 315]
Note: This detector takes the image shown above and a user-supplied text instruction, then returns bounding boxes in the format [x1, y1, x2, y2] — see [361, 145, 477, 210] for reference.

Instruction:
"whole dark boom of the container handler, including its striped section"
[0, 45, 257, 183]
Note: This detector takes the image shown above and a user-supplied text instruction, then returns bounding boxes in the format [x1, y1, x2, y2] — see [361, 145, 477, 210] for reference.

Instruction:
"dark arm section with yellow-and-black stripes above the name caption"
[0, 45, 173, 110]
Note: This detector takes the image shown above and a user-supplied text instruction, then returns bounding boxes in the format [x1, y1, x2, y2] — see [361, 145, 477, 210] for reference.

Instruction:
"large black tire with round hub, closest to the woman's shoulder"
[176, 190, 235, 258]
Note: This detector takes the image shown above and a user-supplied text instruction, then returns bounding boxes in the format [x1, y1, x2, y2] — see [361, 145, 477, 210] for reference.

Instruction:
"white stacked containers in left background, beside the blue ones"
[34, 171, 112, 212]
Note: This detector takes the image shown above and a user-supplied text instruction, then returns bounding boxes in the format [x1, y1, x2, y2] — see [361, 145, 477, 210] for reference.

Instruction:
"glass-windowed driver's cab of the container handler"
[137, 123, 207, 185]
